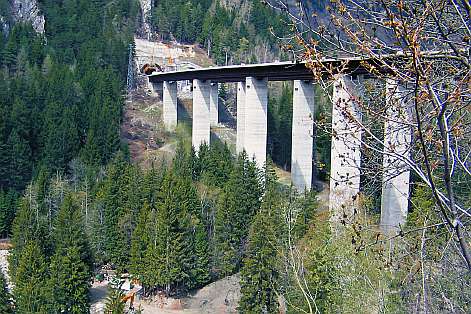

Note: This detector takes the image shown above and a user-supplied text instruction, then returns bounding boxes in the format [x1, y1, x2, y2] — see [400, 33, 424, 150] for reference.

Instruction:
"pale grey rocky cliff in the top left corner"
[7, 0, 45, 34]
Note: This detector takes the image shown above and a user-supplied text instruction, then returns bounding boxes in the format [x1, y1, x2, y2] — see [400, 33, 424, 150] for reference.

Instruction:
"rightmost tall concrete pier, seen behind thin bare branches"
[381, 80, 412, 233]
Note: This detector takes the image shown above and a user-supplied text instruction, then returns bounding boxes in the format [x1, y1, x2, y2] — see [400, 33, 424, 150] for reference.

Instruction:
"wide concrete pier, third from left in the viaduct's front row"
[244, 77, 268, 168]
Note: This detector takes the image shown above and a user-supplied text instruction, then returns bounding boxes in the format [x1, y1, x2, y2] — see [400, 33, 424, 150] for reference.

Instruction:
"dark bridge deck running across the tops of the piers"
[149, 59, 365, 83]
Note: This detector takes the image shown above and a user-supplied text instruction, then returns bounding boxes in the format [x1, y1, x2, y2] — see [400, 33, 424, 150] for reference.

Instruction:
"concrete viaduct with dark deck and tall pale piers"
[149, 60, 410, 230]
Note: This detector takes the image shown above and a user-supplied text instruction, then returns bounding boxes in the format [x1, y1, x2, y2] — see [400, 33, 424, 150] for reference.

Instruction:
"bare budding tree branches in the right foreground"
[267, 0, 471, 271]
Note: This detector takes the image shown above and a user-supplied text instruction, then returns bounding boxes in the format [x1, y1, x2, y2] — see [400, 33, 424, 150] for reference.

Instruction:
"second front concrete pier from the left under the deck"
[192, 80, 211, 151]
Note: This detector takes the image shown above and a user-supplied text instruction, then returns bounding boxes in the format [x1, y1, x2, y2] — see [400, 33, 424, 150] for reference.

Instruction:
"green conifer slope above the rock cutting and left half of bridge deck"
[152, 0, 288, 64]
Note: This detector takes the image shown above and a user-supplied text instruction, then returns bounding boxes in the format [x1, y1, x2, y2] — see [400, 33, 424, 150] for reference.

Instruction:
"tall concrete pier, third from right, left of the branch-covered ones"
[291, 81, 314, 192]
